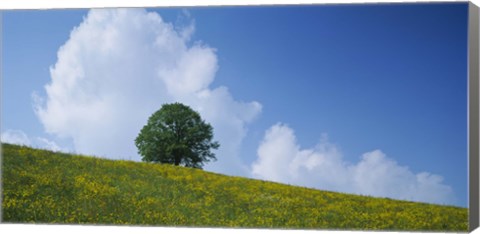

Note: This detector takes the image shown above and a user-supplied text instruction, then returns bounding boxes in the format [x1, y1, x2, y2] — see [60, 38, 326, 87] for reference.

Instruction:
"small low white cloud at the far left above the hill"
[1, 129, 66, 151]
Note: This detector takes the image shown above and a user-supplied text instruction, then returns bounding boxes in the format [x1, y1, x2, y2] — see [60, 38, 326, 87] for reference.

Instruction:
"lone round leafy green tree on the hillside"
[135, 103, 220, 168]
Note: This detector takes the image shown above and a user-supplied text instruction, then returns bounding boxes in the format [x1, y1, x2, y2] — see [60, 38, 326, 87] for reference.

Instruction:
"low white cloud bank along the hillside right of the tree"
[251, 123, 454, 204]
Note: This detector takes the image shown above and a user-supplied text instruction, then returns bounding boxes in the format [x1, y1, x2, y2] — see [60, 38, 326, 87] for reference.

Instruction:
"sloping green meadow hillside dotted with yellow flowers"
[2, 144, 468, 231]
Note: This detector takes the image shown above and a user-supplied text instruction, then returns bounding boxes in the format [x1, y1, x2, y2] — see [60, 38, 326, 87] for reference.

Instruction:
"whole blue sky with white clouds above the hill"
[1, 3, 468, 207]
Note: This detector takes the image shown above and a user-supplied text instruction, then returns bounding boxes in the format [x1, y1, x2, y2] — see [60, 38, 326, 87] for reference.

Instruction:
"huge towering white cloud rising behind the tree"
[34, 9, 261, 175]
